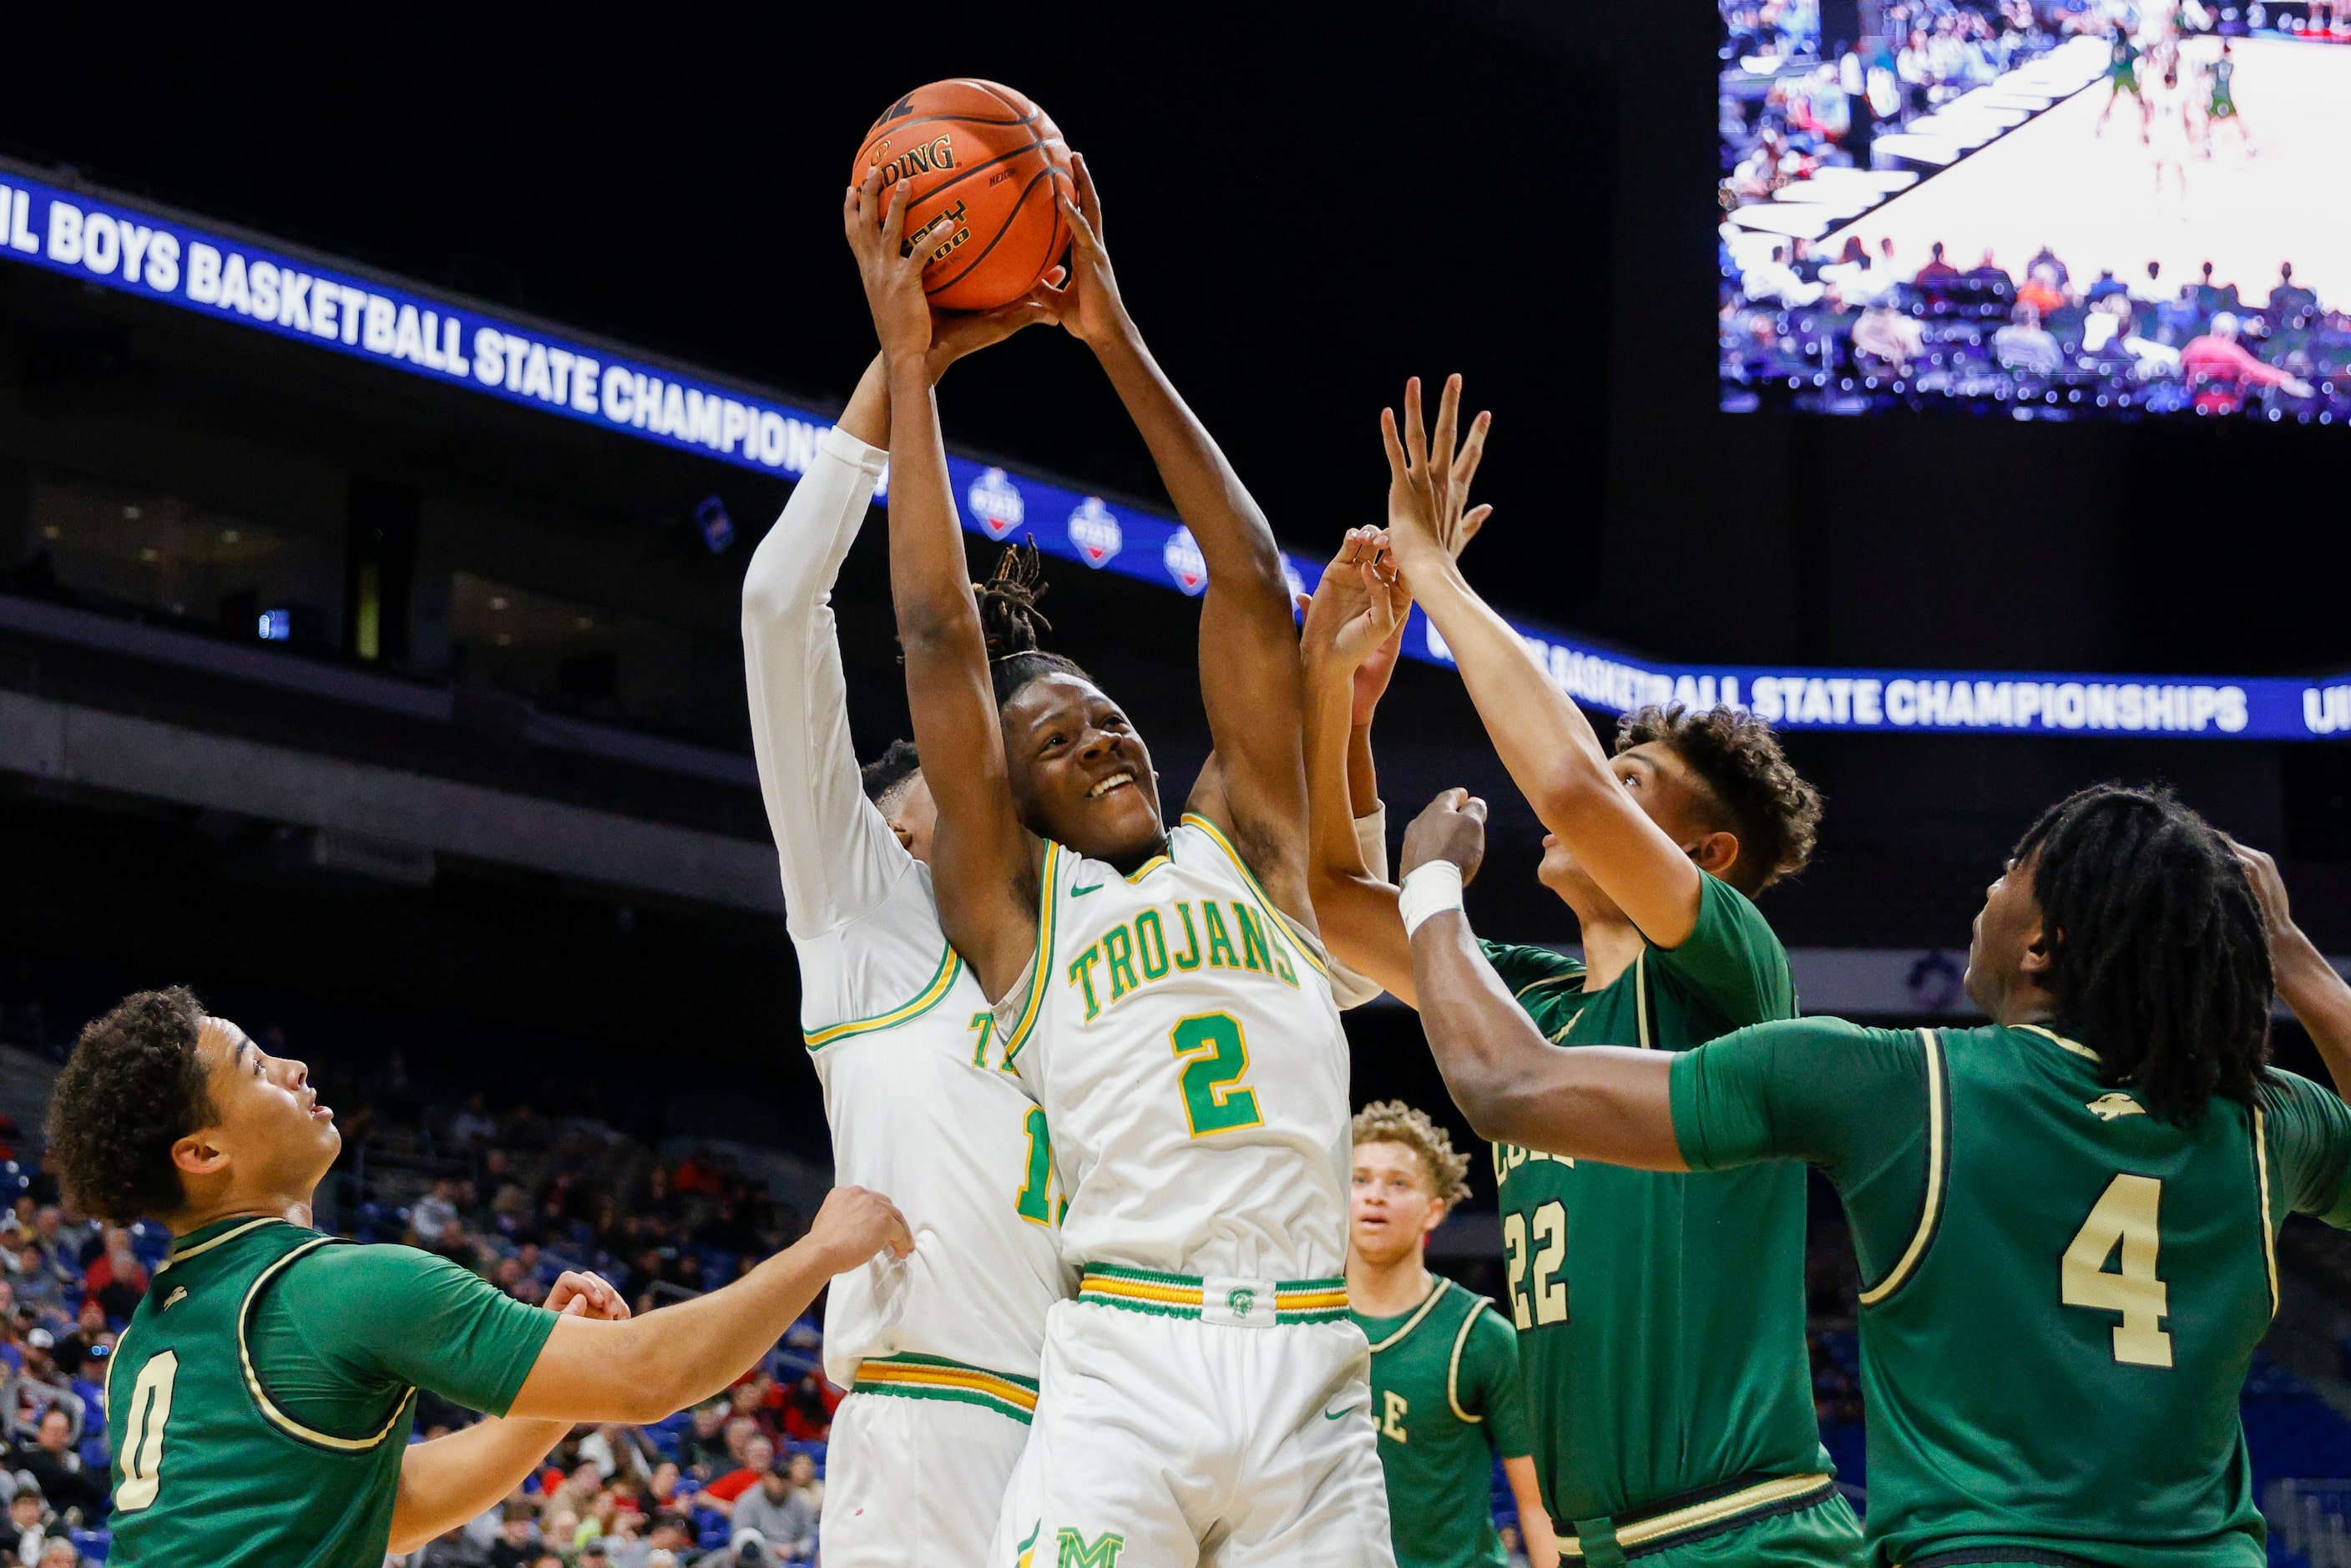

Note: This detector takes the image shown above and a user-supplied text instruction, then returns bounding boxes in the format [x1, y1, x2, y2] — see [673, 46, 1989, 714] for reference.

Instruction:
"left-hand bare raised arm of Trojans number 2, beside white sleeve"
[842, 169, 1037, 997]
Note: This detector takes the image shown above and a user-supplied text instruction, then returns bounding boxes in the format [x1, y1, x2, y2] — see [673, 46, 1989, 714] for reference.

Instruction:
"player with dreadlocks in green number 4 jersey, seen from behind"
[1403, 785, 2351, 1568]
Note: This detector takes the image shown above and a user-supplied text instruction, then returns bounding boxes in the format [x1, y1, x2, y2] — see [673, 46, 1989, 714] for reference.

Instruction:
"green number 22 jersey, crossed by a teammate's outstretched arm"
[1486, 877, 1859, 1561]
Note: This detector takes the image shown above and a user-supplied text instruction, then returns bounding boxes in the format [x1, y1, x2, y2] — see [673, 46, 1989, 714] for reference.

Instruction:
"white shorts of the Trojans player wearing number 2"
[992, 1302, 1394, 1568]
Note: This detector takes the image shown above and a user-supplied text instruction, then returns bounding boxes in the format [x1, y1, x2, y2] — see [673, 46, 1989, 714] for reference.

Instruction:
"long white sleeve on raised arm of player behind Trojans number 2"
[743, 426, 914, 940]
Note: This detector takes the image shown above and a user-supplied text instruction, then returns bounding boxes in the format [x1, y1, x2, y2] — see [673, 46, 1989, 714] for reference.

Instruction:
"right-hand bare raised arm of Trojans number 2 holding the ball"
[1051, 155, 1314, 924]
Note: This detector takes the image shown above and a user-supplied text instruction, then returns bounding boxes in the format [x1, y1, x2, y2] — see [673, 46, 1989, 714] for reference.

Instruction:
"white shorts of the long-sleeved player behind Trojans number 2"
[821, 1394, 1028, 1568]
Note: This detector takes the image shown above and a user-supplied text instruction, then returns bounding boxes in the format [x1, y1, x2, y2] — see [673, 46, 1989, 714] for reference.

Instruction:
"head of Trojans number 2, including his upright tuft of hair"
[980, 545, 1166, 865]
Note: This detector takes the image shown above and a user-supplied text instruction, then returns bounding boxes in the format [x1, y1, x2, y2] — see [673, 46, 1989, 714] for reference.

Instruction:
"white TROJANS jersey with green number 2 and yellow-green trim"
[997, 816, 1349, 1281]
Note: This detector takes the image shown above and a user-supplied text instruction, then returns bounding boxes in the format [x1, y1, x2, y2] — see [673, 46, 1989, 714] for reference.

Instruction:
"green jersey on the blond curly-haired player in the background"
[1347, 1279, 1528, 1568]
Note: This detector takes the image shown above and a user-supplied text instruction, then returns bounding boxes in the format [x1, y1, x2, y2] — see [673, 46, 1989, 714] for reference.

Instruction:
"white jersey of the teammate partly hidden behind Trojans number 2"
[795, 861, 1069, 1387]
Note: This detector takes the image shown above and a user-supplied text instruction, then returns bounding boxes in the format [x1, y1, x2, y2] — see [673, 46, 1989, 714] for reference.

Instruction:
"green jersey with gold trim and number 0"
[106, 1217, 555, 1568]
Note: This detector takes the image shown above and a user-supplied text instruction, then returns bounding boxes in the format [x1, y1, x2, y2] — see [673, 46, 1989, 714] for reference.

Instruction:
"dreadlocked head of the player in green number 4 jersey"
[1968, 783, 2273, 1121]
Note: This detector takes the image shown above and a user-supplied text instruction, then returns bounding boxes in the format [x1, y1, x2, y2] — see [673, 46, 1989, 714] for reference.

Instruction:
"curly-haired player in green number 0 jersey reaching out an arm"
[49, 988, 908, 1568]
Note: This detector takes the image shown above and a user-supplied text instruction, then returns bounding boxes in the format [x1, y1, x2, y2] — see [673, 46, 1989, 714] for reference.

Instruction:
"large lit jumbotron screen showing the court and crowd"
[1718, 0, 2351, 423]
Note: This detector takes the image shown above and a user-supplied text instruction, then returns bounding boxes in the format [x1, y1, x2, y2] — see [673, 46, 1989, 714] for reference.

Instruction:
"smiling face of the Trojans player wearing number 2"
[1004, 675, 1166, 865]
